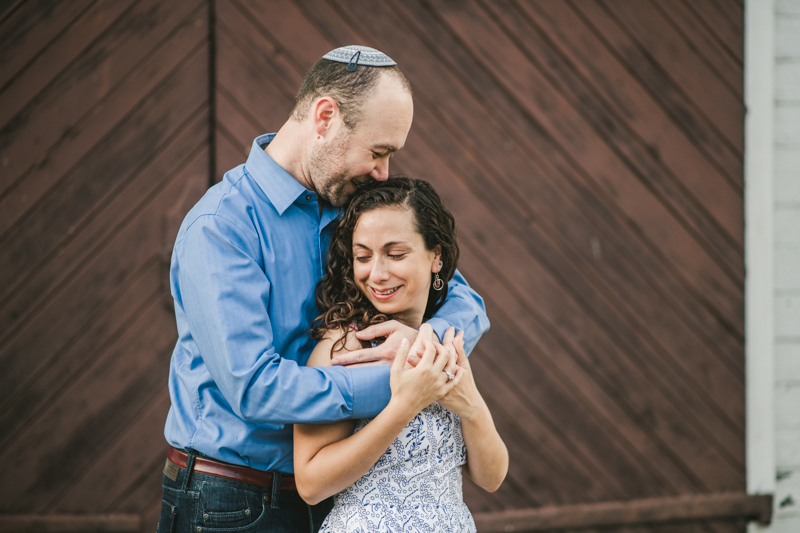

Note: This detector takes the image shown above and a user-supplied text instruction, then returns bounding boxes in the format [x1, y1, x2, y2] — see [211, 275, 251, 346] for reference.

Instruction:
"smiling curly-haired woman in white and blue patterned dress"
[294, 177, 508, 532]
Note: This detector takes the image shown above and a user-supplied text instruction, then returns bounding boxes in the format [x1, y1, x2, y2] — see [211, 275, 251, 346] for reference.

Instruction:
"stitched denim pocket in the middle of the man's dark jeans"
[194, 481, 265, 532]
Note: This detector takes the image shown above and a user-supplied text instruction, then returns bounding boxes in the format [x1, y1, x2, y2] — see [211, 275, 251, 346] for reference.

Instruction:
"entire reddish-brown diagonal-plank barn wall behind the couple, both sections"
[0, 0, 745, 533]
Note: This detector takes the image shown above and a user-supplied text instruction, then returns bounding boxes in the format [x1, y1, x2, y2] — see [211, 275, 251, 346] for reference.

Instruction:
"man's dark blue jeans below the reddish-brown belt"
[157, 456, 333, 533]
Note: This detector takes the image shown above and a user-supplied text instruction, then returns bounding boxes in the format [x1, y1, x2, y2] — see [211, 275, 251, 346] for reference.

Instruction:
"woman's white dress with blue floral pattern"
[320, 403, 475, 533]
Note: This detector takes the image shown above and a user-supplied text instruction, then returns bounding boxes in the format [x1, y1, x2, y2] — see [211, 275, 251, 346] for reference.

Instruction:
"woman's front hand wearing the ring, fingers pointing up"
[389, 324, 463, 420]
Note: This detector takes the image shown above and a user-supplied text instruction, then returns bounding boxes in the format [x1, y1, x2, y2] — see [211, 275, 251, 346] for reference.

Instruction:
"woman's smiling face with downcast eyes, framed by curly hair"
[353, 207, 441, 328]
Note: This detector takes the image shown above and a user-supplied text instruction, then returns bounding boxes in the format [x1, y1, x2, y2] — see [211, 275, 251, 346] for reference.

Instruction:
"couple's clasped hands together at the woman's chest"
[331, 320, 482, 418]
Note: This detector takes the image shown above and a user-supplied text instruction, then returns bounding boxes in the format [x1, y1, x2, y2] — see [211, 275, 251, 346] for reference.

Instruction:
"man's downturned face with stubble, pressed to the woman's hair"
[309, 74, 414, 207]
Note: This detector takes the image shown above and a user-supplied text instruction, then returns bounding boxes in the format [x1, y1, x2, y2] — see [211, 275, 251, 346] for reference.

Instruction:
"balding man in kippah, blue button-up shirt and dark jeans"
[159, 46, 488, 533]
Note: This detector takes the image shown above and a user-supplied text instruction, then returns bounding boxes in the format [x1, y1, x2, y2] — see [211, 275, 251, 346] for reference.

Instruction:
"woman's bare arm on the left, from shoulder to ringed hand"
[294, 328, 460, 505]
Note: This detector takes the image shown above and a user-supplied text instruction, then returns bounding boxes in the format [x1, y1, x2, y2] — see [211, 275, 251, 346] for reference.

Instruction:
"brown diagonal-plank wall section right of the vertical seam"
[216, 0, 745, 532]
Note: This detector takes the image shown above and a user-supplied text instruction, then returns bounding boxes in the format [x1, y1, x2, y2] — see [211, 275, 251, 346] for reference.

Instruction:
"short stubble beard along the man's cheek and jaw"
[309, 130, 356, 207]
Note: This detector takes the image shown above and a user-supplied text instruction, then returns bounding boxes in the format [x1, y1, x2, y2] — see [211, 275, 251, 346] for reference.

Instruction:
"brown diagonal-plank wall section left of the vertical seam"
[0, 0, 210, 531]
